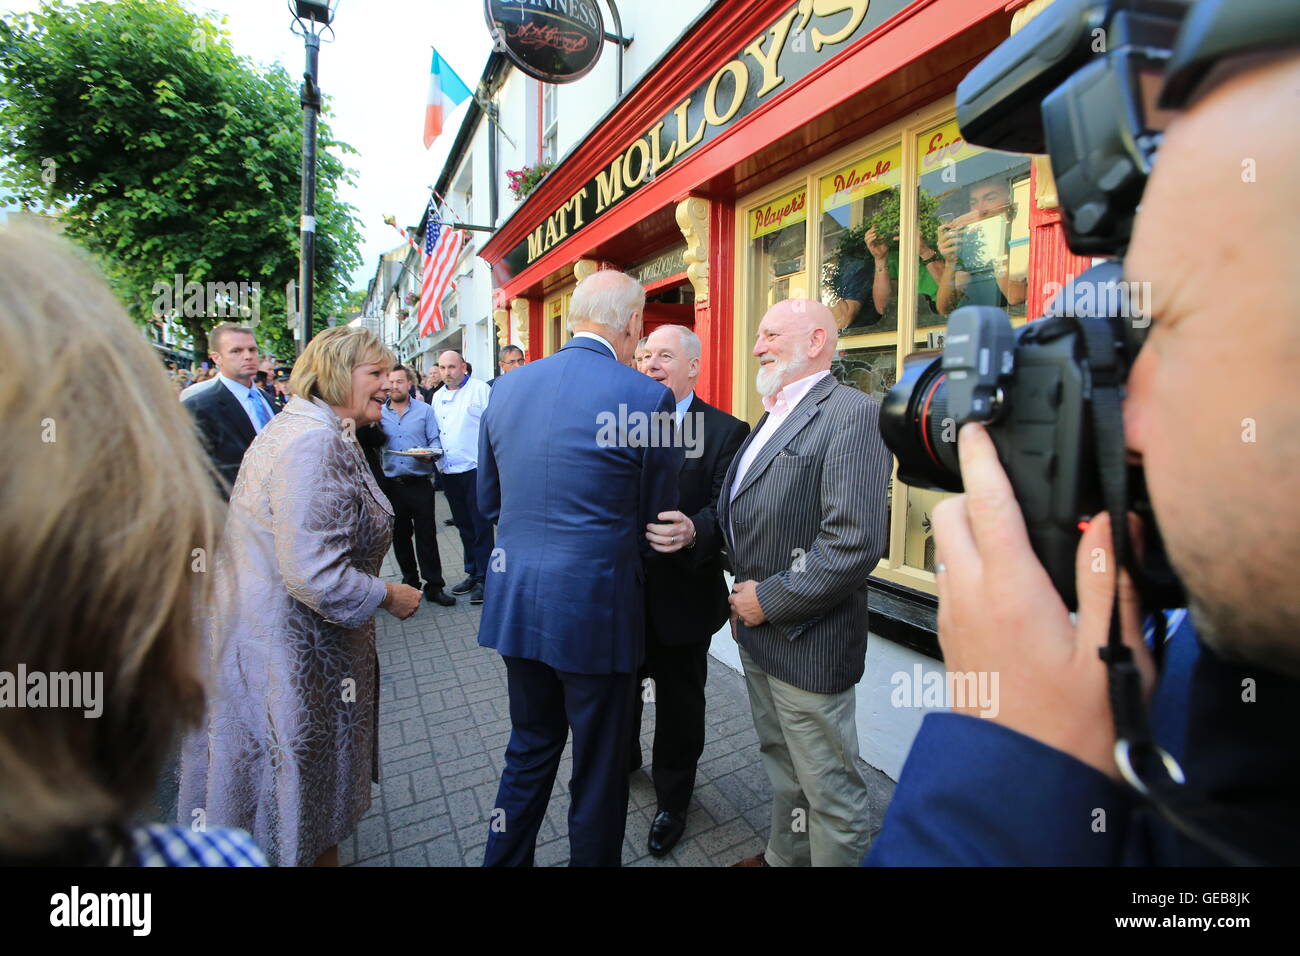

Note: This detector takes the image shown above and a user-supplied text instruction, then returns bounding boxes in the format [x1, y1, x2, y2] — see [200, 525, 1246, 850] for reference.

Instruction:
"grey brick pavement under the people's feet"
[339, 494, 893, 866]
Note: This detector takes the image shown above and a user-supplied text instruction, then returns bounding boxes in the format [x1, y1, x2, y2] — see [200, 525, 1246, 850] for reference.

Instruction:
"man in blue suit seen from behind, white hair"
[478, 271, 683, 866]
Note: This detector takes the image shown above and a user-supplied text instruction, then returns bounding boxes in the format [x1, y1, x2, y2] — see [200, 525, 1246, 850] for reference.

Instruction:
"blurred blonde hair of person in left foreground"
[0, 228, 224, 862]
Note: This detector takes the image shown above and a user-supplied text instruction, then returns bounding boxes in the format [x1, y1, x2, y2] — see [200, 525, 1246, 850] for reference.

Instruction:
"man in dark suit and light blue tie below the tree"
[181, 323, 276, 499]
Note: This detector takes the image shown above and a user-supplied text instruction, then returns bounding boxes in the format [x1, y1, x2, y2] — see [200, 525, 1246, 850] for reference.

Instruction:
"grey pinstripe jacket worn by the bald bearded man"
[718, 376, 892, 693]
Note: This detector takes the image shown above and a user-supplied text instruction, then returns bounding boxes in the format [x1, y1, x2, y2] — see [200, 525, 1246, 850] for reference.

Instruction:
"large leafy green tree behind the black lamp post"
[0, 0, 360, 358]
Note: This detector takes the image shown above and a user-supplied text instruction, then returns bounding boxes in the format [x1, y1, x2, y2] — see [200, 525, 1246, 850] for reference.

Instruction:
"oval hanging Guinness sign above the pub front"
[484, 0, 605, 83]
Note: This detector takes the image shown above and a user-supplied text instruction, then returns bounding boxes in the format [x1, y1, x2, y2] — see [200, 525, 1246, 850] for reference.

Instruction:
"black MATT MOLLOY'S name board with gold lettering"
[504, 0, 909, 274]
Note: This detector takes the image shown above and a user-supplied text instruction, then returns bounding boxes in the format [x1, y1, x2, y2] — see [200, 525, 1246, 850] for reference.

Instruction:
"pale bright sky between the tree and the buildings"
[0, 0, 491, 289]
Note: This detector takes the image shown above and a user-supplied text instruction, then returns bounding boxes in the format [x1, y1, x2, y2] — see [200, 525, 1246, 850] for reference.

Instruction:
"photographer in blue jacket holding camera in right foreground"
[867, 0, 1300, 866]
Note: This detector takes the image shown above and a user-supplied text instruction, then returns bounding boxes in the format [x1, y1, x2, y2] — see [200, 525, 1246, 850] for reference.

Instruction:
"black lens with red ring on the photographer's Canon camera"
[880, 351, 962, 492]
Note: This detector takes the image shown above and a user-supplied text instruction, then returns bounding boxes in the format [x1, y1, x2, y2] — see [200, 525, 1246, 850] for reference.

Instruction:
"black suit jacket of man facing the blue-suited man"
[646, 395, 749, 645]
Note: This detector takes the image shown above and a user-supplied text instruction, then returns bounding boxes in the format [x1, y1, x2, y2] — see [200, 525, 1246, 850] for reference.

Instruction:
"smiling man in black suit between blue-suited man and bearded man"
[631, 325, 749, 856]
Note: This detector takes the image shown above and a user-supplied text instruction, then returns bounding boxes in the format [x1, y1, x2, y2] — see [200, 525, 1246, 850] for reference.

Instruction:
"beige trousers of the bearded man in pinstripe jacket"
[740, 648, 870, 866]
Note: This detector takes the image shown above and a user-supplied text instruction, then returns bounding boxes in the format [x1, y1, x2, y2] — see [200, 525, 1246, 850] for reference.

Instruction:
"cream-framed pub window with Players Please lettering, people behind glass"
[737, 112, 1031, 591]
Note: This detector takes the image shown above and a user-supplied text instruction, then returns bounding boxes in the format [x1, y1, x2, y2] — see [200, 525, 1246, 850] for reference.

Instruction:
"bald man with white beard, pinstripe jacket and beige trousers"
[718, 299, 891, 866]
